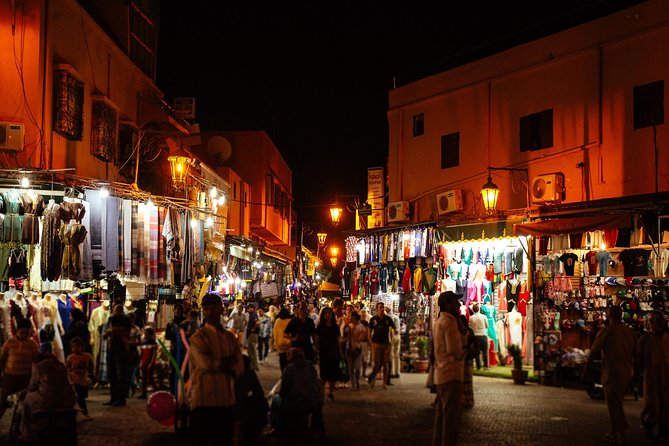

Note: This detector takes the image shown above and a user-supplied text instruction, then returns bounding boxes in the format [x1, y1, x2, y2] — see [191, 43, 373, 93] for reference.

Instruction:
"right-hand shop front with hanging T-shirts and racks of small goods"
[514, 210, 669, 385]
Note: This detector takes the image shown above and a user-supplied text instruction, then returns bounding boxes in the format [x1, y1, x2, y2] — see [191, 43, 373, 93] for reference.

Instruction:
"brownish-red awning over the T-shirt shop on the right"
[513, 212, 634, 236]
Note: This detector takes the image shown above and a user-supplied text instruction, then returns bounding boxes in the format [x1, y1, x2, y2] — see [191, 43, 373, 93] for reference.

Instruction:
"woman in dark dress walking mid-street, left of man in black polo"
[316, 307, 342, 401]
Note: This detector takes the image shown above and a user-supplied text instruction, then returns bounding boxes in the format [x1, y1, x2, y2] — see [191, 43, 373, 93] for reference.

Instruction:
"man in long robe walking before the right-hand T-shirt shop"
[588, 306, 635, 444]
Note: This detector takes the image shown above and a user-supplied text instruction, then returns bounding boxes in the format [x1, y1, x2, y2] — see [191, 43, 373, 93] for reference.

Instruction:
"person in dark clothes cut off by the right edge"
[635, 310, 669, 442]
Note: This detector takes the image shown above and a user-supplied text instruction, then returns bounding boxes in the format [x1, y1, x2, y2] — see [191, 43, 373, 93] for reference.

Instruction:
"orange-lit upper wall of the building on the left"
[0, 0, 164, 179]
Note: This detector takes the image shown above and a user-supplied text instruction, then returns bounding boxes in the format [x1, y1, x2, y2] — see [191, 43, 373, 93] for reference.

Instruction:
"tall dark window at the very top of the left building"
[128, 2, 157, 79]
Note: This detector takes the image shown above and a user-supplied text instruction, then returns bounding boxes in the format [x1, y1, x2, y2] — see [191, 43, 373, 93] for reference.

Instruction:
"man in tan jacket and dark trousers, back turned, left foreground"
[189, 294, 244, 446]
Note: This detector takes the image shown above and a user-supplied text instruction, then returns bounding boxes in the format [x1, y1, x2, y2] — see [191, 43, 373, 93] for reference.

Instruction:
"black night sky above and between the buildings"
[157, 0, 640, 230]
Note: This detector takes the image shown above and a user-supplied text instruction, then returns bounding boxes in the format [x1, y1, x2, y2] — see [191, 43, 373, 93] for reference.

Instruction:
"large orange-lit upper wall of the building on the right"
[388, 0, 669, 221]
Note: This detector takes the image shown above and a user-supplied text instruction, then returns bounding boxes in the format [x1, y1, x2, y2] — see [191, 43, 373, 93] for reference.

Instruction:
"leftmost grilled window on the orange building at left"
[53, 69, 84, 141]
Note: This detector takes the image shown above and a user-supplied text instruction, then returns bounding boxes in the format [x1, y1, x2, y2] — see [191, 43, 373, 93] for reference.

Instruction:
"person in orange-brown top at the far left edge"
[0, 319, 38, 419]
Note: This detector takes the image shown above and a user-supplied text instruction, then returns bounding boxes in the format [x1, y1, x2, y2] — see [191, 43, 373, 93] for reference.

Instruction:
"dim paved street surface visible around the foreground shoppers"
[0, 358, 656, 446]
